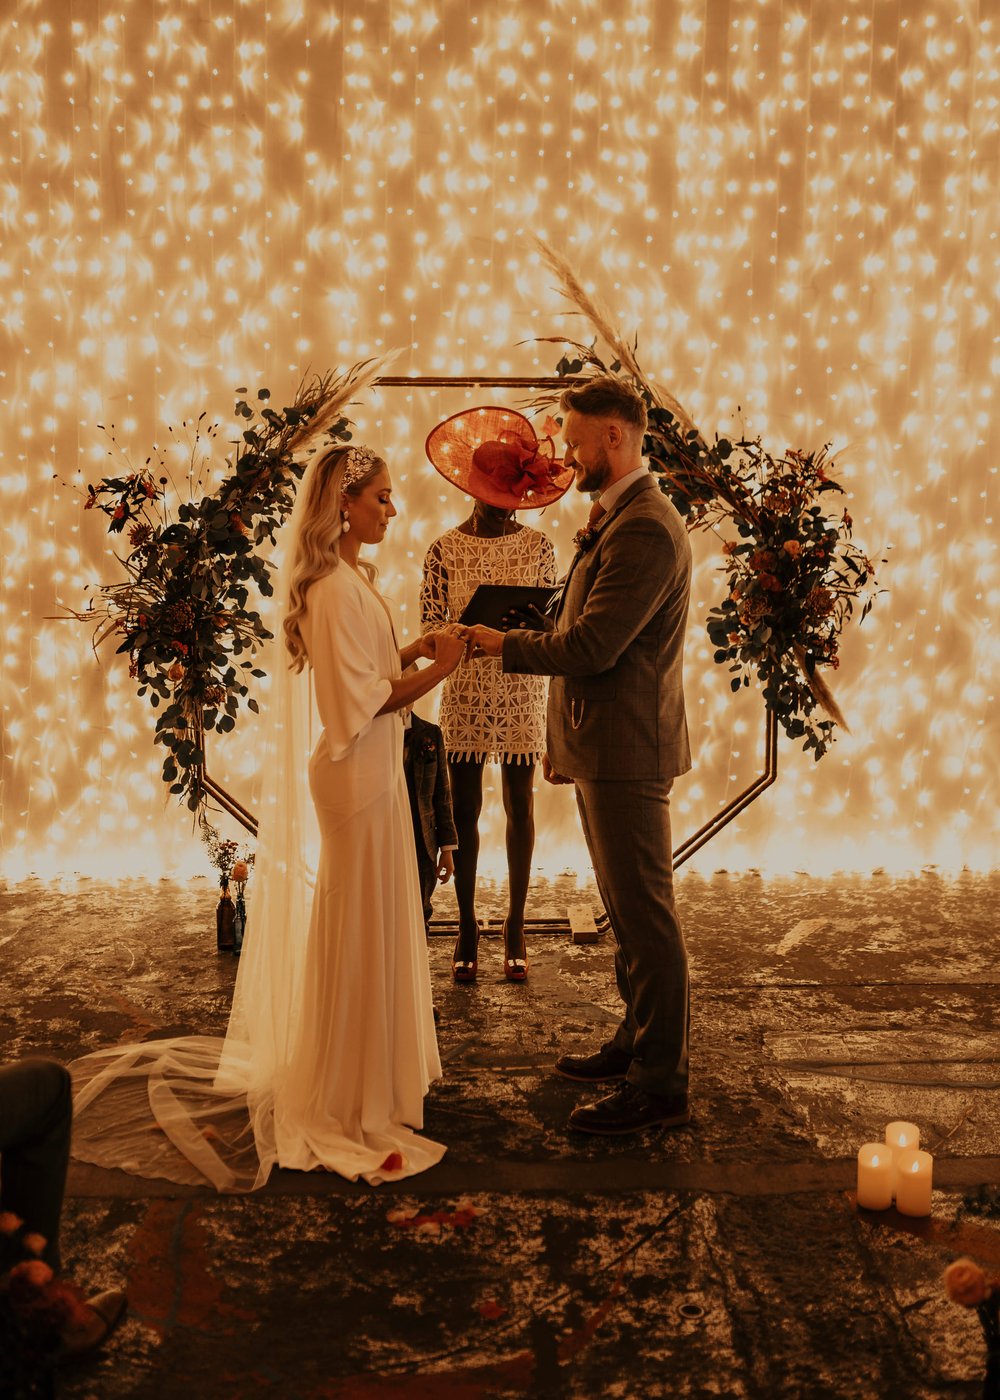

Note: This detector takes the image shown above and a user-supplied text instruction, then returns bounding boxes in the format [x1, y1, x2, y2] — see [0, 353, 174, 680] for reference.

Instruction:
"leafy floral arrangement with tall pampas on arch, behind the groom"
[535, 239, 877, 759]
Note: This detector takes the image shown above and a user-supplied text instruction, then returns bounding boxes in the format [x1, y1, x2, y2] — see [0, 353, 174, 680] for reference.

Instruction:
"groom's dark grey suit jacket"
[503, 476, 690, 780]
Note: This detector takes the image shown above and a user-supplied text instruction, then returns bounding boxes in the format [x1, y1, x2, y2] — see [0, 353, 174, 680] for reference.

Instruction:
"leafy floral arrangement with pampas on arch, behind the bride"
[71, 357, 391, 817]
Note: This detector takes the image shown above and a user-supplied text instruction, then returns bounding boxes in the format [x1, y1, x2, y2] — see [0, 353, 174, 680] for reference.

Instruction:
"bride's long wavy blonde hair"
[282, 444, 385, 671]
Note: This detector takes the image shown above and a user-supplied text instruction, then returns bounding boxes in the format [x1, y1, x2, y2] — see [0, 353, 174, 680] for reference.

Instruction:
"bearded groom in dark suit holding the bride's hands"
[469, 375, 690, 1134]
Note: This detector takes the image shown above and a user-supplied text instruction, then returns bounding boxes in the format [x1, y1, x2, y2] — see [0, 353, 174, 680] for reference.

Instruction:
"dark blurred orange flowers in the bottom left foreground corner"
[0, 1211, 87, 1400]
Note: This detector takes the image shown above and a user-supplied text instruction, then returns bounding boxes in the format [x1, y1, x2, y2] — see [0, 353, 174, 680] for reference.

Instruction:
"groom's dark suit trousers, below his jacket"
[576, 778, 690, 1095]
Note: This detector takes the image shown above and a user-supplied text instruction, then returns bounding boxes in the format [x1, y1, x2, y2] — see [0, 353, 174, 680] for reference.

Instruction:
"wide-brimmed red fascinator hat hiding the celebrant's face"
[426, 407, 573, 511]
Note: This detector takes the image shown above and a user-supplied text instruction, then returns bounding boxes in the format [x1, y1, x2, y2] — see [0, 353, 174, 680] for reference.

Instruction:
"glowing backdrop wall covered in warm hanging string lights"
[0, 0, 1000, 876]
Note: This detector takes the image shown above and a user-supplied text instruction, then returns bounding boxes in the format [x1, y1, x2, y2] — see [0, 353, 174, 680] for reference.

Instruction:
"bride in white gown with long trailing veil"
[71, 445, 465, 1190]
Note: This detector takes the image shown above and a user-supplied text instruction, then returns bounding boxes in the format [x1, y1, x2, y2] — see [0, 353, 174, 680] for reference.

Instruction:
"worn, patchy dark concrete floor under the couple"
[0, 871, 1000, 1400]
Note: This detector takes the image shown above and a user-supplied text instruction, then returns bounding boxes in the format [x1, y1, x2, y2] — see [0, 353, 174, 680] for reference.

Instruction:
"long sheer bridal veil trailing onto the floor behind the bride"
[70, 449, 324, 1190]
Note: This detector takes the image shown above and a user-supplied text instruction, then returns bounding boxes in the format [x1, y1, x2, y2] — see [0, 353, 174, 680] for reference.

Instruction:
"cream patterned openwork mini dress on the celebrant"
[420, 525, 556, 763]
